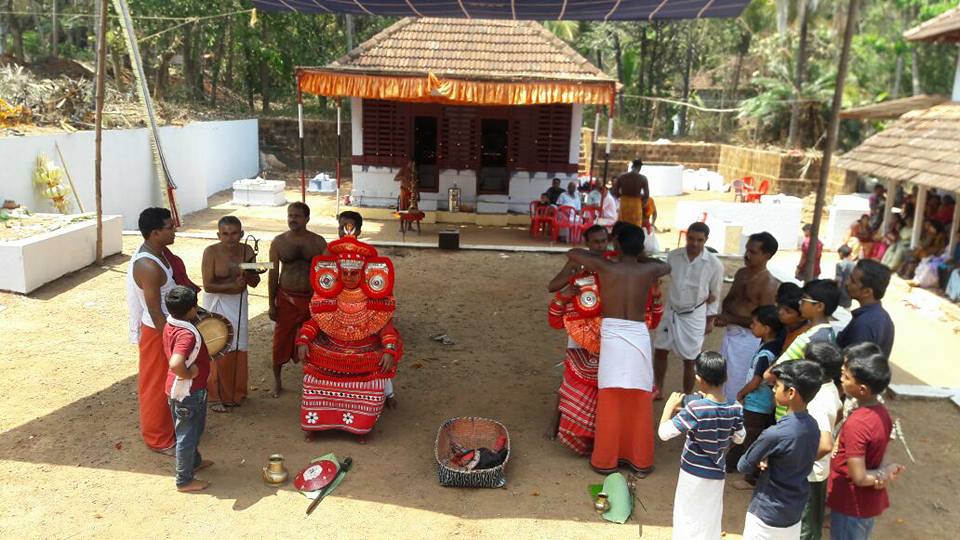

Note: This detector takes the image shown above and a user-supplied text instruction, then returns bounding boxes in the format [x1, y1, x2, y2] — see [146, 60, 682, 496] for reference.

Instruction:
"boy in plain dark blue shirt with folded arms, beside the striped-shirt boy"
[737, 360, 823, 540]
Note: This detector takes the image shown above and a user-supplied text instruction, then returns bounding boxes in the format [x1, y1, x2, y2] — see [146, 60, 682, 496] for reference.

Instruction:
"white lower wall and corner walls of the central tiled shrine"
[350, 98, 583, 214]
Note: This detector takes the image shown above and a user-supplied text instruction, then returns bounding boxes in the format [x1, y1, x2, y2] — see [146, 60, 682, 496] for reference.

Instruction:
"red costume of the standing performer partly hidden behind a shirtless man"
[547, 253, 663, 456]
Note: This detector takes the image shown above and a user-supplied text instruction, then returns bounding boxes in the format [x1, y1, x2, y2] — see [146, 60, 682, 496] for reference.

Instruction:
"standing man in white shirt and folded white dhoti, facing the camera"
[653, 222, 731, 399]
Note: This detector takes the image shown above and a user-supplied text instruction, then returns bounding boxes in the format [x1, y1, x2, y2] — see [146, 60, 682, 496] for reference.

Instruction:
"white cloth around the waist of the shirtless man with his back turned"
[597, 318, 653, 392]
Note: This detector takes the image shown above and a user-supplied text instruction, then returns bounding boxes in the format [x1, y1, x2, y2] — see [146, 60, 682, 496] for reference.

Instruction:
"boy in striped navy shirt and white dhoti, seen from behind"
[658, 351, 746, 540]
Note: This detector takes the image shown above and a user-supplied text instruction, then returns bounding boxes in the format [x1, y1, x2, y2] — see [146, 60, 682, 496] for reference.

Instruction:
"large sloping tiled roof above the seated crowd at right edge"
[839, 101, 960, 191]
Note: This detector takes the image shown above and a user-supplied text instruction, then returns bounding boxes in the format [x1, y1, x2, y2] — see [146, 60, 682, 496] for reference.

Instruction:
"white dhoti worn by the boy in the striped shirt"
[673, 469, 724, 540]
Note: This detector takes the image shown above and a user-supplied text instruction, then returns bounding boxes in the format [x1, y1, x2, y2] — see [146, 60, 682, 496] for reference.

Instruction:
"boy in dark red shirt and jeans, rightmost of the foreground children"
[827, 343, 905, 540]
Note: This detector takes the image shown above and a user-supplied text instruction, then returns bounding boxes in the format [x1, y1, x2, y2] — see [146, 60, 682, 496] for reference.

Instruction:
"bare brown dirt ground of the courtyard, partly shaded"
[0, 233, 960, 539]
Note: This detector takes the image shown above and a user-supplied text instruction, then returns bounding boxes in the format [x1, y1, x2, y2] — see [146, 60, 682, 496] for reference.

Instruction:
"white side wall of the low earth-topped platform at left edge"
[0, 215, 123, 294]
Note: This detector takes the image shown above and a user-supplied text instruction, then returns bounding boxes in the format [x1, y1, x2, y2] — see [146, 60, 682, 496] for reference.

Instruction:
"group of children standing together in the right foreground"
[659, 280, 904, 540]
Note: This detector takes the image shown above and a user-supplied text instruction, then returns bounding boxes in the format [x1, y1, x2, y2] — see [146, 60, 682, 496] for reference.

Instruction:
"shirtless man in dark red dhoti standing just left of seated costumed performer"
[267, 202, 327, 397]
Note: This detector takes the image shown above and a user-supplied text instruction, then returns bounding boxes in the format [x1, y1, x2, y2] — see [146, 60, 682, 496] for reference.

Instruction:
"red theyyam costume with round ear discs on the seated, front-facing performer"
[297, 236, 403, 435]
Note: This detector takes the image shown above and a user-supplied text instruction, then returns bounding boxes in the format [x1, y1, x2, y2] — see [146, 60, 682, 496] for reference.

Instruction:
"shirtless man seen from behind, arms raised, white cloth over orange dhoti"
[567, 224, 670, 478]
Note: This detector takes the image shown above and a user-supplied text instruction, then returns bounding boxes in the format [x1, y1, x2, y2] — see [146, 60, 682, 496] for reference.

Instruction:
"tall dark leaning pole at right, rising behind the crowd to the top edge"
[803, 0, 860, 281]
